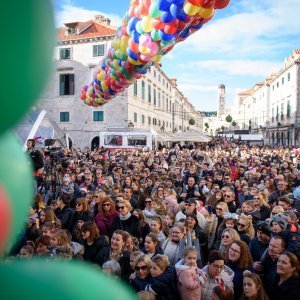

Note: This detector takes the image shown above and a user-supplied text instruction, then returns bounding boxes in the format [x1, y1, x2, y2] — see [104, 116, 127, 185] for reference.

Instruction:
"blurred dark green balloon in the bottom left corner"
[0, 260, 137, 300]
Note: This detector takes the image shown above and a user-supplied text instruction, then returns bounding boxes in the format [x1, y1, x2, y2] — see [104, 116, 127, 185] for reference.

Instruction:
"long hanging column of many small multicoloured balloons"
[81, 0, 230, 106]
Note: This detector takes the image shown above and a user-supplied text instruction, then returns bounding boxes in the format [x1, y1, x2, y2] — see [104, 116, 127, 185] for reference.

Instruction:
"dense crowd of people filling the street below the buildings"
[9, 138, 300, 300]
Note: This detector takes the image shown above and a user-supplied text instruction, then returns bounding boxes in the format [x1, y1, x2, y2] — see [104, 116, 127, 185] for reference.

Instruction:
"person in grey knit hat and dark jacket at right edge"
[270, 213, 300, 258]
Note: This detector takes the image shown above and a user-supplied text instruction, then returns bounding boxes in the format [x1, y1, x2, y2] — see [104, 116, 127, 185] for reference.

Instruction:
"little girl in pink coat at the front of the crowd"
[175, 246, 207, 300]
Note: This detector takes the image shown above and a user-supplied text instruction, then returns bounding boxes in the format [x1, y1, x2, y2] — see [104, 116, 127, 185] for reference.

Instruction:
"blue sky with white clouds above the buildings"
[52, 0, 300, 111]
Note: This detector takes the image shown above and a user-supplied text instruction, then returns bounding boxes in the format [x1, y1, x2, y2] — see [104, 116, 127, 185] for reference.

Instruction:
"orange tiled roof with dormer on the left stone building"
[57, 20, 116, 42]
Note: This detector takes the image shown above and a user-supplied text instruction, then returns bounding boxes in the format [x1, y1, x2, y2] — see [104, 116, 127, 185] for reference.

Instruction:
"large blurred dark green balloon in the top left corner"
[0, 0, 55, 132]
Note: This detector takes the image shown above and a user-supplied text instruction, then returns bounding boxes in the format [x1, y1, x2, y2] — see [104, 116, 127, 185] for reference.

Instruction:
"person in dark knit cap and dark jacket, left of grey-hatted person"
[249, 221, 272, 261]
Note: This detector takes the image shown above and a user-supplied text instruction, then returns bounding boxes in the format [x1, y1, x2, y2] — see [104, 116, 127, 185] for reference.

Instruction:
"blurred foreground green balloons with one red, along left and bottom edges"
[0, 0, 136, 300]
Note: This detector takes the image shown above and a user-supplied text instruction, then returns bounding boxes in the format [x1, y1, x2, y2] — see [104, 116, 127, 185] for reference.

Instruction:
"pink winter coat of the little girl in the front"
[175, 259, 206, 300]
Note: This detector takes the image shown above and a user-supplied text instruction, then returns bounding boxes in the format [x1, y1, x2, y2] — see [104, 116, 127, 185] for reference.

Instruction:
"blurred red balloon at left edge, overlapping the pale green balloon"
[0, 186, 11, 253]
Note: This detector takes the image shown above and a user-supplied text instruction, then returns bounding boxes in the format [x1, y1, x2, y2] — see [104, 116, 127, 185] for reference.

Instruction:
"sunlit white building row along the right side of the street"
[231, 49, 300, 146]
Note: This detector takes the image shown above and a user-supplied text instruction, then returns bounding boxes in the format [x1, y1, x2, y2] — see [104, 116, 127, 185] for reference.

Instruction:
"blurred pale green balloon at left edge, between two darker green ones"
[0, 132, 33, 246]
